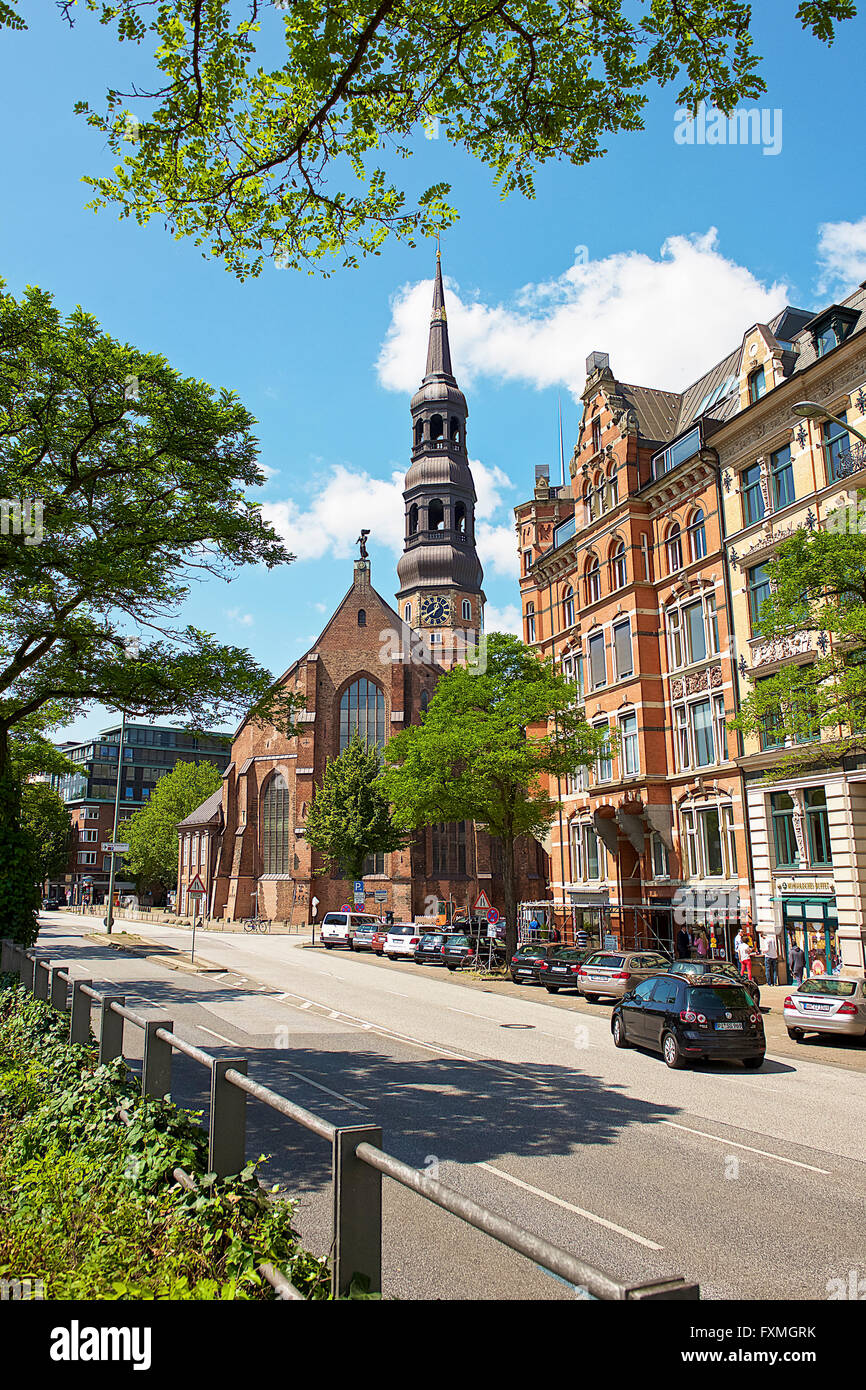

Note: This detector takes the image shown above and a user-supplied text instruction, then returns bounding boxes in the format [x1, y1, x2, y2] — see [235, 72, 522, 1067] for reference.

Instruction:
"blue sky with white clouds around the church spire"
[0, 0, 866, 737]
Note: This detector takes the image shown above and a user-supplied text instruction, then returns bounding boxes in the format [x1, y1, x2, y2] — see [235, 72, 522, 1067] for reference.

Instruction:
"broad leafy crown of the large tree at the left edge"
[0, 282, 301, 931]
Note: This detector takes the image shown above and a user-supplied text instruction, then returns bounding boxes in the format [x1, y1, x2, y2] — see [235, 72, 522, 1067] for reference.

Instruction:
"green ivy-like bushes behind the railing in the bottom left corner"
[0, 977, 329, 1300]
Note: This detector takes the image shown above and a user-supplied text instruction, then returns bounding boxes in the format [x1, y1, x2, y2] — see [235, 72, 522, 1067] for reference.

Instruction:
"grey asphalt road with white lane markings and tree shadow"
[23, 913, 866, 1300]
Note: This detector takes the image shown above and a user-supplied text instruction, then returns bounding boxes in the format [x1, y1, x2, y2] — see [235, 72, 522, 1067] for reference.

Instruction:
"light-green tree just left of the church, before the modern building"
[118, 762, 222, 890]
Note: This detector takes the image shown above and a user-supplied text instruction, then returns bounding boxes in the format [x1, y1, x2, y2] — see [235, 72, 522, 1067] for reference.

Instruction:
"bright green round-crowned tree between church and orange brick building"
[385, 632, 606, 954]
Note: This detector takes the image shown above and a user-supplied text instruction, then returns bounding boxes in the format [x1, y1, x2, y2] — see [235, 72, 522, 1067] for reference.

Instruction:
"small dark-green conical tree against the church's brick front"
[306, 738, 407, 878]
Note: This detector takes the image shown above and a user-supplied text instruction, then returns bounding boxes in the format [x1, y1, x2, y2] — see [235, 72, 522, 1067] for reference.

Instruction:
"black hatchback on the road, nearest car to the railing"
[610, 972, 767, 1068]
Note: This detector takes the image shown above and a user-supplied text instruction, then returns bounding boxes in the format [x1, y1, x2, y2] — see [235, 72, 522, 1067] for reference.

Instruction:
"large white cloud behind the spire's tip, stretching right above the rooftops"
[378, 227, 787, 399]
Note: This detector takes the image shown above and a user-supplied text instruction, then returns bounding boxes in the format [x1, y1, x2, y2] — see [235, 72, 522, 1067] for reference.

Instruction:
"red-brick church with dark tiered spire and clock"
[178, 257, 546, 923]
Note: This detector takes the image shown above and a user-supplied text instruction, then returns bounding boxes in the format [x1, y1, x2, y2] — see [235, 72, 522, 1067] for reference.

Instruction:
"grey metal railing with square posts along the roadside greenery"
[0, 938, 701, 1300]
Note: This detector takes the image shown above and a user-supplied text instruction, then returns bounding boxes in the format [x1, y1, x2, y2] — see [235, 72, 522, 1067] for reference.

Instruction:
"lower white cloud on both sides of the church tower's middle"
[261, 459, 517, 574]
